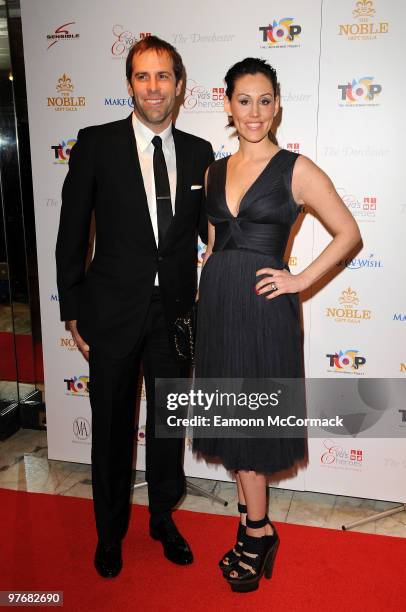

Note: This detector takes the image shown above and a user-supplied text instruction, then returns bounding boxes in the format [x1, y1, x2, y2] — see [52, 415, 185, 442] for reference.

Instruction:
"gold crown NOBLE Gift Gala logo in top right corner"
[338, 0, 389, 40]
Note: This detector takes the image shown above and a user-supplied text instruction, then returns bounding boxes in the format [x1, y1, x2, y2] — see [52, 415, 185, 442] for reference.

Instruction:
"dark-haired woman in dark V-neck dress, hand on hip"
[193, 58, 360, 591]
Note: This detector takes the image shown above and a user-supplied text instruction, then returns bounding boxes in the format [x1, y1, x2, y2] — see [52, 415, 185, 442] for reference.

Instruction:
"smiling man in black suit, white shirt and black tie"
[56, 36, 213, 577]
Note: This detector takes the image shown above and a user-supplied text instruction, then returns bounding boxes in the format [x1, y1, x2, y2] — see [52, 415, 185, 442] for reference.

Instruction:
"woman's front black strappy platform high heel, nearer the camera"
[226, 516, 279, 593]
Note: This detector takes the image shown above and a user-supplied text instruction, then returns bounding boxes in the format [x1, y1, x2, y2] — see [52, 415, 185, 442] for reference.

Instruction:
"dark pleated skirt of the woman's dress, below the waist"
[193, 250, 306, 474]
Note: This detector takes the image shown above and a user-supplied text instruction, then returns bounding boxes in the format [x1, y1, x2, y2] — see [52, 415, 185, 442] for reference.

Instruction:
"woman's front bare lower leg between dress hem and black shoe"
[237, 470, 273, 537]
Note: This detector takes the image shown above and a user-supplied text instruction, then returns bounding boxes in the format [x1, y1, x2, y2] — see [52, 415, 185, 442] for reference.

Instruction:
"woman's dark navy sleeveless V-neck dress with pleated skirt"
[193, 149, 305, 474]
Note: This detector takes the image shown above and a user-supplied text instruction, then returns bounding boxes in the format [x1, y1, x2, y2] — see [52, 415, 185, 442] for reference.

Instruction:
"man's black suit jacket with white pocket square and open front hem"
[56, 115, 213, 356]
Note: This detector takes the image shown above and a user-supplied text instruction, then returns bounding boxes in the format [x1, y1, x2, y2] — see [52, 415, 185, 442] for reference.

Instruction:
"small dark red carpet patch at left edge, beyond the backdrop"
[0, 332, 44, 383]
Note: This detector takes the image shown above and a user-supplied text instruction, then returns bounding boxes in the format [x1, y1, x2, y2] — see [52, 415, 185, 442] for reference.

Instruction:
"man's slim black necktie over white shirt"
[152, 136, 173, 244]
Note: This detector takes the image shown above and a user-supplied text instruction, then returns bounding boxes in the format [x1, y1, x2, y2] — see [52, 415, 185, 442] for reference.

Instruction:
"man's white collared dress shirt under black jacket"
[132, 113, 176, 285]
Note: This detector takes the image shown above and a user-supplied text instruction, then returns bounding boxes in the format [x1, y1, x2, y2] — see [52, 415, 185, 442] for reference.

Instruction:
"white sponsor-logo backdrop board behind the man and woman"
[22, 0, 406, 501]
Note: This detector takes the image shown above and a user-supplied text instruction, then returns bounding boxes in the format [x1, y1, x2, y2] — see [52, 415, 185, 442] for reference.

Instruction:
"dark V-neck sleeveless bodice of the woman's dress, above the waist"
[206, 149, 301, 259]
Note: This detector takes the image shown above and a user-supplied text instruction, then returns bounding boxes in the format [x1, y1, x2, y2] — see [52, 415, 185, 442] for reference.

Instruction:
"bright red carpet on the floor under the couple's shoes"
[0, 489, 406, 612]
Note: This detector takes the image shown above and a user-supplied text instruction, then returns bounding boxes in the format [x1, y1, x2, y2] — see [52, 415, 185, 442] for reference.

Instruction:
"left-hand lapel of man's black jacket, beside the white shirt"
[123, 113, 156, 247]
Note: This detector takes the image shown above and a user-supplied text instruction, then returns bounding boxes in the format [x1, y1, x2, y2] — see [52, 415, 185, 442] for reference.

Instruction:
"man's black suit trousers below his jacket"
[89, 288, 190, 544]
